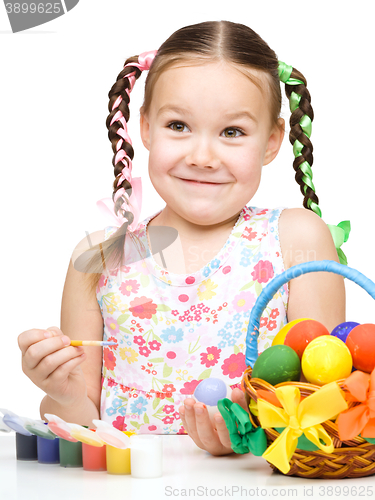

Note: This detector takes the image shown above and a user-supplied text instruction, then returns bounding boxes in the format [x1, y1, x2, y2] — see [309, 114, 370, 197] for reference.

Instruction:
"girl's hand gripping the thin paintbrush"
[18, 326, 87, 406]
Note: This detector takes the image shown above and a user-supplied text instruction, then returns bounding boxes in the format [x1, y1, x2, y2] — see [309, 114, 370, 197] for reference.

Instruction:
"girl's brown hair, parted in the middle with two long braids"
[81, 21, 318, 293]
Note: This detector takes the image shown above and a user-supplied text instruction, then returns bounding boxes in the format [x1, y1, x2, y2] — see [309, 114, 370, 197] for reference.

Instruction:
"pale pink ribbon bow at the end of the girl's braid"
[96, 177, 142, 232]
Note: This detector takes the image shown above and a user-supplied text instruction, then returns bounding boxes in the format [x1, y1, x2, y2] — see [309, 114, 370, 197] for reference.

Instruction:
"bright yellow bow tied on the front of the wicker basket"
[258, 382, 348, 474]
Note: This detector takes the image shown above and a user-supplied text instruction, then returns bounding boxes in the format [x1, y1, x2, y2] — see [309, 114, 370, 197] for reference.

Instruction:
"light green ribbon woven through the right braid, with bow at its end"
[278, 61, 351, 265]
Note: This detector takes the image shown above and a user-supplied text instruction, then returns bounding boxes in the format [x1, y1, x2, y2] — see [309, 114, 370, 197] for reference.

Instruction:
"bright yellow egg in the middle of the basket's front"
[301, 335, 353, 385]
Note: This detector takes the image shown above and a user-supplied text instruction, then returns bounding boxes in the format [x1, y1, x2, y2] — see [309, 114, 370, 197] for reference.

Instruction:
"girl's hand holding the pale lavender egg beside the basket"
[179, 388, 248, 455]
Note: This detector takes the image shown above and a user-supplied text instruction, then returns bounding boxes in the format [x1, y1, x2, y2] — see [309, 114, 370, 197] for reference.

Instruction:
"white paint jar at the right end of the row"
[130, 434, 163, 478]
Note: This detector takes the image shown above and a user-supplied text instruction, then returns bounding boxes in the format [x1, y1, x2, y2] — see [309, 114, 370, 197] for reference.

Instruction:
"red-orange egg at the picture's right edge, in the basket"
[345, 323, 375, 373]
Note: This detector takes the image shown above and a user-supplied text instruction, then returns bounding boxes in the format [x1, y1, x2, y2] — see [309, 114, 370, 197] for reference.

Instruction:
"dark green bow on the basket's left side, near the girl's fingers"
[217, 398, 267, 457]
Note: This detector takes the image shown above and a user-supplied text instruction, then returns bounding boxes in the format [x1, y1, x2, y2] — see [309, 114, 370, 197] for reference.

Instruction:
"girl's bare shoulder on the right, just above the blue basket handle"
[279, 208, 337, 269]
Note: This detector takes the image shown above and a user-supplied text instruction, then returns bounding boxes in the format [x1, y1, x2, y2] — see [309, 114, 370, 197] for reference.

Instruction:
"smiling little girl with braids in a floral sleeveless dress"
[19, 21, 345, 455]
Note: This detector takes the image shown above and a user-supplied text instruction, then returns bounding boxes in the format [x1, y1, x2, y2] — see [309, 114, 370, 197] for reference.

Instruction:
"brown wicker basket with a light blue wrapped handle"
[242, 261, 375, 479]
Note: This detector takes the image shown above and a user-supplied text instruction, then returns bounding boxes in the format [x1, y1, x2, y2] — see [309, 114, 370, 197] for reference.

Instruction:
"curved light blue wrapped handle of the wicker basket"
[246, 260, 375, 367]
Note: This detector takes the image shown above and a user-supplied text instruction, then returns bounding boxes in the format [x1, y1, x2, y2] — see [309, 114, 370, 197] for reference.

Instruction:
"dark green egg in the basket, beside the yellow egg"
[251, 345, 301, 385]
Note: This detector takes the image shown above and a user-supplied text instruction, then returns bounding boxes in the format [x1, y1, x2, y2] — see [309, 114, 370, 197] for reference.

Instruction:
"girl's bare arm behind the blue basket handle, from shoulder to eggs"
[279, 208, 345, 331]
